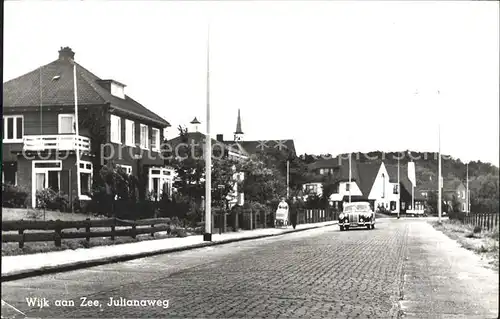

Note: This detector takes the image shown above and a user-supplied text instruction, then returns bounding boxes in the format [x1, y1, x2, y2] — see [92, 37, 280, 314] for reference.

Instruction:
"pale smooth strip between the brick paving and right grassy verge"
[400, 223, 498, 319]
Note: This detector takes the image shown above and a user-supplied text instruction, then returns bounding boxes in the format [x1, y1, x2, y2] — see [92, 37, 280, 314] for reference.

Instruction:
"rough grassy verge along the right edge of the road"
[431, 220, 499, 271]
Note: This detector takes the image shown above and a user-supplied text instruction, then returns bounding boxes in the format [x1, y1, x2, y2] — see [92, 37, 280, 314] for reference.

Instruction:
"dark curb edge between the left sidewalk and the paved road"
[1, 221, 337, 282]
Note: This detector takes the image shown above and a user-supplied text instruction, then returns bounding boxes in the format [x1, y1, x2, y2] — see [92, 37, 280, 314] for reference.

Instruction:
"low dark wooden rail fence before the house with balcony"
[2, 218, 170, 248]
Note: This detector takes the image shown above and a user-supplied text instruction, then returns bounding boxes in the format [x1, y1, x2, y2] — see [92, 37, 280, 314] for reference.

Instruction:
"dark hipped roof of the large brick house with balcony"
[3, 48, 170, 127]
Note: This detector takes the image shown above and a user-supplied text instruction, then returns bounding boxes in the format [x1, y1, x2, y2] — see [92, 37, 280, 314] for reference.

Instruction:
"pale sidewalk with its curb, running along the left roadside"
[2, 221, 337, 281]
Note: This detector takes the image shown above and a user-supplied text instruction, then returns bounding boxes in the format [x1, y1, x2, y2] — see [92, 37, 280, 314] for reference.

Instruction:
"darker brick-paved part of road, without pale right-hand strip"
[2, 219, 498, 318]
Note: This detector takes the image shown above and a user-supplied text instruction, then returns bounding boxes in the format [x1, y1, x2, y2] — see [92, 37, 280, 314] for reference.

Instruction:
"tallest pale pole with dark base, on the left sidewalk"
[203, 24, 212, 241]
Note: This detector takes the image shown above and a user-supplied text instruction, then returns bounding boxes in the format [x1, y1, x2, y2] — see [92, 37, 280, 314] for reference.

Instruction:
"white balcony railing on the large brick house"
[23, 134, 90, 152]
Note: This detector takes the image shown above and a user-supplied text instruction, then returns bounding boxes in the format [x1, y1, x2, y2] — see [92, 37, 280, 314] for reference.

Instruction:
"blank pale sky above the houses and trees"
[3, 1, 500, 166]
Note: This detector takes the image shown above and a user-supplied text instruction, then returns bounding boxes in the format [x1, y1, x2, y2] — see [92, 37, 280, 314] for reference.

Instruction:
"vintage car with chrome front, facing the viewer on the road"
[339, 202, 375, 231]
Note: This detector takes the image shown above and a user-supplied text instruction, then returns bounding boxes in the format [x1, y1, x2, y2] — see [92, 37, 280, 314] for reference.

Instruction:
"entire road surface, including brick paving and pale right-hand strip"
[2, 219, 498, 319]
